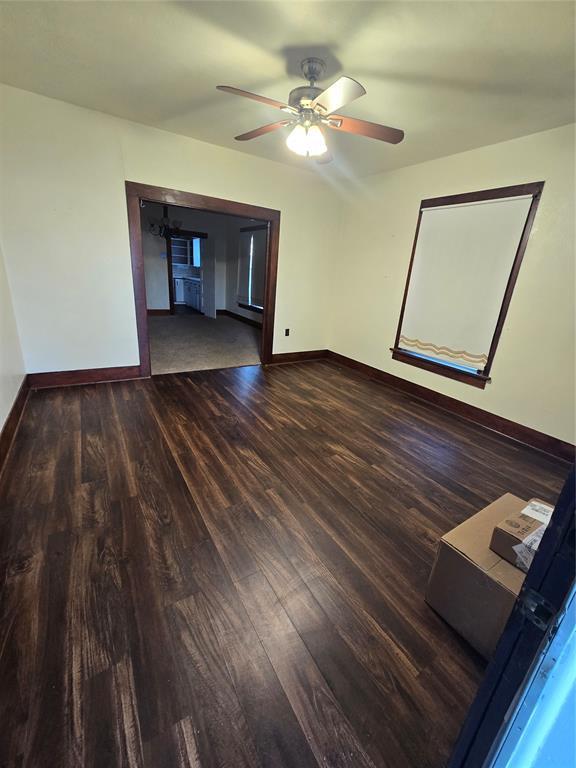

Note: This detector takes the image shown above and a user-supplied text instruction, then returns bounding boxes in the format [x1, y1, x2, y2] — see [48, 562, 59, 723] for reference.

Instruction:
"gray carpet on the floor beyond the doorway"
[148, 314, 261, 374]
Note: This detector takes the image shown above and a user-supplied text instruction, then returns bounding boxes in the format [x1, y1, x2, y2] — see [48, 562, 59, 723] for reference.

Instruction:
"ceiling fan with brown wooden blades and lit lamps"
[216, 57, 404, 157]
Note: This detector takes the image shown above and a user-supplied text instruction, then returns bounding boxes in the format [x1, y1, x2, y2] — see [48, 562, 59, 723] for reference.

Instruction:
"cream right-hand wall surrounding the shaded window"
[328, 126, 575, 442]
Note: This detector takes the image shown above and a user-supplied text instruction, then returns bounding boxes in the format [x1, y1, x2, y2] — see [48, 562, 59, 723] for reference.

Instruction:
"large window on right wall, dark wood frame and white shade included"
[391, 182, 544, 388]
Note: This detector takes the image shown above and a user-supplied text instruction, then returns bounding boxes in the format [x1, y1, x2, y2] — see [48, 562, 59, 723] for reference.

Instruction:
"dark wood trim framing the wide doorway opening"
[125, 181, 280, 377]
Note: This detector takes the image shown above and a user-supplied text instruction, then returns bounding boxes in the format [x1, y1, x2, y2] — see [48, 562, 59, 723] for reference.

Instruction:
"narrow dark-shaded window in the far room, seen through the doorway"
[237, 225, 268, 312]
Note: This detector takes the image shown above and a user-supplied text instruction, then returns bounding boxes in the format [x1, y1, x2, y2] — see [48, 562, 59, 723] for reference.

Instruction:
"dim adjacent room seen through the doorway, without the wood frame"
[140, 202, 268, 374]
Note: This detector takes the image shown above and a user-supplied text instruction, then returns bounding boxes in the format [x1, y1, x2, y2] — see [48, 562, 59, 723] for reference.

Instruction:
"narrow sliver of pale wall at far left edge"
[0, 242, 25, 430]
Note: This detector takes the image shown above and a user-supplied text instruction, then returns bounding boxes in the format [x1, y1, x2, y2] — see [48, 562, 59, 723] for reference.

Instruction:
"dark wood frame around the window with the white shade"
[390, 181, 544, 389]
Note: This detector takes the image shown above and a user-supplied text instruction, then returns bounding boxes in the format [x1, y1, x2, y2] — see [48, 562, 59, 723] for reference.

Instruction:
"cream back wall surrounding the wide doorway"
[0, 86, 338, 372]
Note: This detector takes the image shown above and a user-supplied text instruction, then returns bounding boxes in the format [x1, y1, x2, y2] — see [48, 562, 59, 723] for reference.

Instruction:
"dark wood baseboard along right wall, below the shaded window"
[326, 351, 576, 462]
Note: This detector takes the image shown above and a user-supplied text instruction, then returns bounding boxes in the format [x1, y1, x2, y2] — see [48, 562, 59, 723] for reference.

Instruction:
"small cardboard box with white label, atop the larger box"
[490, 499, 554, 573]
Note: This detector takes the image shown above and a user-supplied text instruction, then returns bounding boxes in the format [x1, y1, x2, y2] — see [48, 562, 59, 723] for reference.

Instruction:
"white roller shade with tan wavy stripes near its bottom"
[399, 195, 532, 370]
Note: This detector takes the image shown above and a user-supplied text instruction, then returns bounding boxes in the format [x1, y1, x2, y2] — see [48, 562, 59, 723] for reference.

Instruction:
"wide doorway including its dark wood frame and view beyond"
[126, 182, 280, 376]
